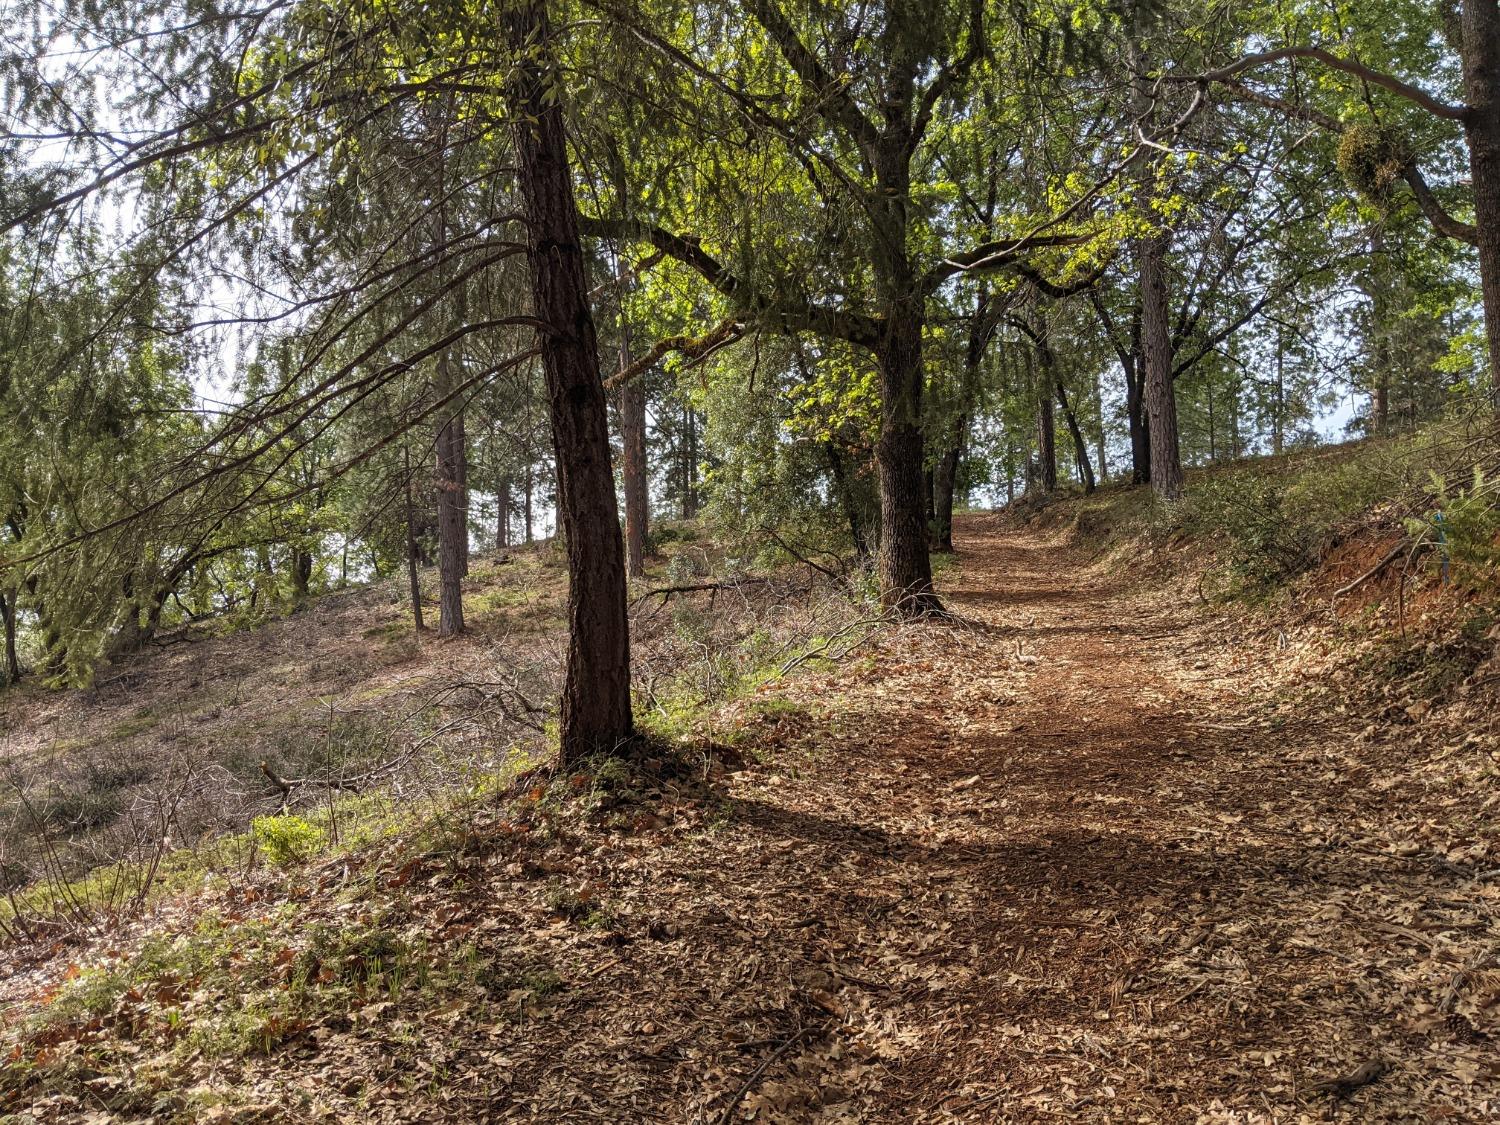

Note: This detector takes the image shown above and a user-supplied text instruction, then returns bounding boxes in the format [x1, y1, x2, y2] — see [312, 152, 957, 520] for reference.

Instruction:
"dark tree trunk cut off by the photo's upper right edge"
[1460, 0, 1500, 405]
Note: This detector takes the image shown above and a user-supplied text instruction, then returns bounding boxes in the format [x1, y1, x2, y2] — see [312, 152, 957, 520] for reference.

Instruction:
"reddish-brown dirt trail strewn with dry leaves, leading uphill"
[684, 516, 1500, 1122]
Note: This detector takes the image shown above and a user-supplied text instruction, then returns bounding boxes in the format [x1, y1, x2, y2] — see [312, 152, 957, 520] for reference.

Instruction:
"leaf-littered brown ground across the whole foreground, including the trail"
[0, 515, 1500, 1124]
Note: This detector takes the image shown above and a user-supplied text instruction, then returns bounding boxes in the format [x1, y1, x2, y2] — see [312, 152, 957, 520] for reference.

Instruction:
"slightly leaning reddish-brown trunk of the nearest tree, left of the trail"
[506, 0, 635, 764]
